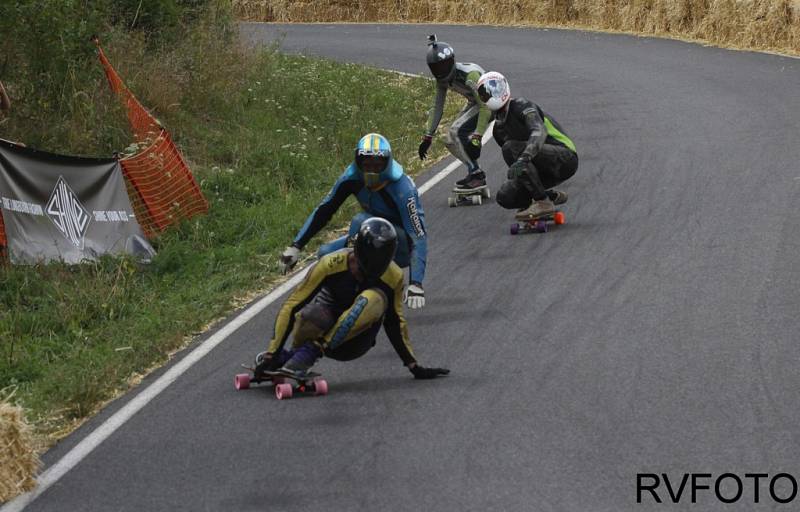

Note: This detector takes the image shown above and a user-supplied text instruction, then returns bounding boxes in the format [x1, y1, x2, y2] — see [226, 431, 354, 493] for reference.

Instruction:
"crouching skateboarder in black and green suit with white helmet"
[478, 71, 578, 220]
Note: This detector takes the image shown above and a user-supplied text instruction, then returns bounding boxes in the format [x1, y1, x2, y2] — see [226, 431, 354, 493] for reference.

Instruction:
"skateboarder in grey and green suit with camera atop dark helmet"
[419, 35, 492, 192]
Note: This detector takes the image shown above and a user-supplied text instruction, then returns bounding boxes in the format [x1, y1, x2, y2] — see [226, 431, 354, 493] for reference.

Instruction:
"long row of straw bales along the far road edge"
[233, 0, 800, 54]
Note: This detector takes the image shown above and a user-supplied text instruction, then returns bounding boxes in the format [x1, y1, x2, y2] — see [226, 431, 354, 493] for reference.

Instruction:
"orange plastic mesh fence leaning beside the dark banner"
[95, 40, 208, 237]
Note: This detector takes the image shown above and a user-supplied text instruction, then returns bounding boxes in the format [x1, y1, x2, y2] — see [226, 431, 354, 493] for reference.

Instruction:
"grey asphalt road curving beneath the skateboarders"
[12, 24, 800, 512]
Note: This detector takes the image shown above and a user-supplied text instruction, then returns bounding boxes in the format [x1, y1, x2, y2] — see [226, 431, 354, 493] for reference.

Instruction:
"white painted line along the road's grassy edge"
[0, 121, 493, 512]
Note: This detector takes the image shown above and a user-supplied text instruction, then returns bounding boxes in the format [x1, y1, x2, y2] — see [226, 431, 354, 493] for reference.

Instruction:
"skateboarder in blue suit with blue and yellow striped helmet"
[281, 133, 428, 309]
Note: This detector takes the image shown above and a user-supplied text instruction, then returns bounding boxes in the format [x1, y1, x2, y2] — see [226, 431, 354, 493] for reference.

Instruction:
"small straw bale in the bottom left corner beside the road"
[0, 400, 39, 503]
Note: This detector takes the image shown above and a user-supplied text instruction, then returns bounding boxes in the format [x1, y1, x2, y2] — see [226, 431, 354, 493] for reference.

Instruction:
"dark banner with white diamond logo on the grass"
[0, 140, 152, 263]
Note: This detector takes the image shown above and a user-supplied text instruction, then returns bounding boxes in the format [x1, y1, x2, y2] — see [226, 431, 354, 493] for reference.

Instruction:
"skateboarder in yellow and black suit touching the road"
[253, 217, 450, 379]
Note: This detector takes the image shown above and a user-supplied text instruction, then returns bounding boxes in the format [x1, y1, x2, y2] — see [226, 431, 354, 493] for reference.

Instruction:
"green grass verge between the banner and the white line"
[0, 36, 461, 444]
